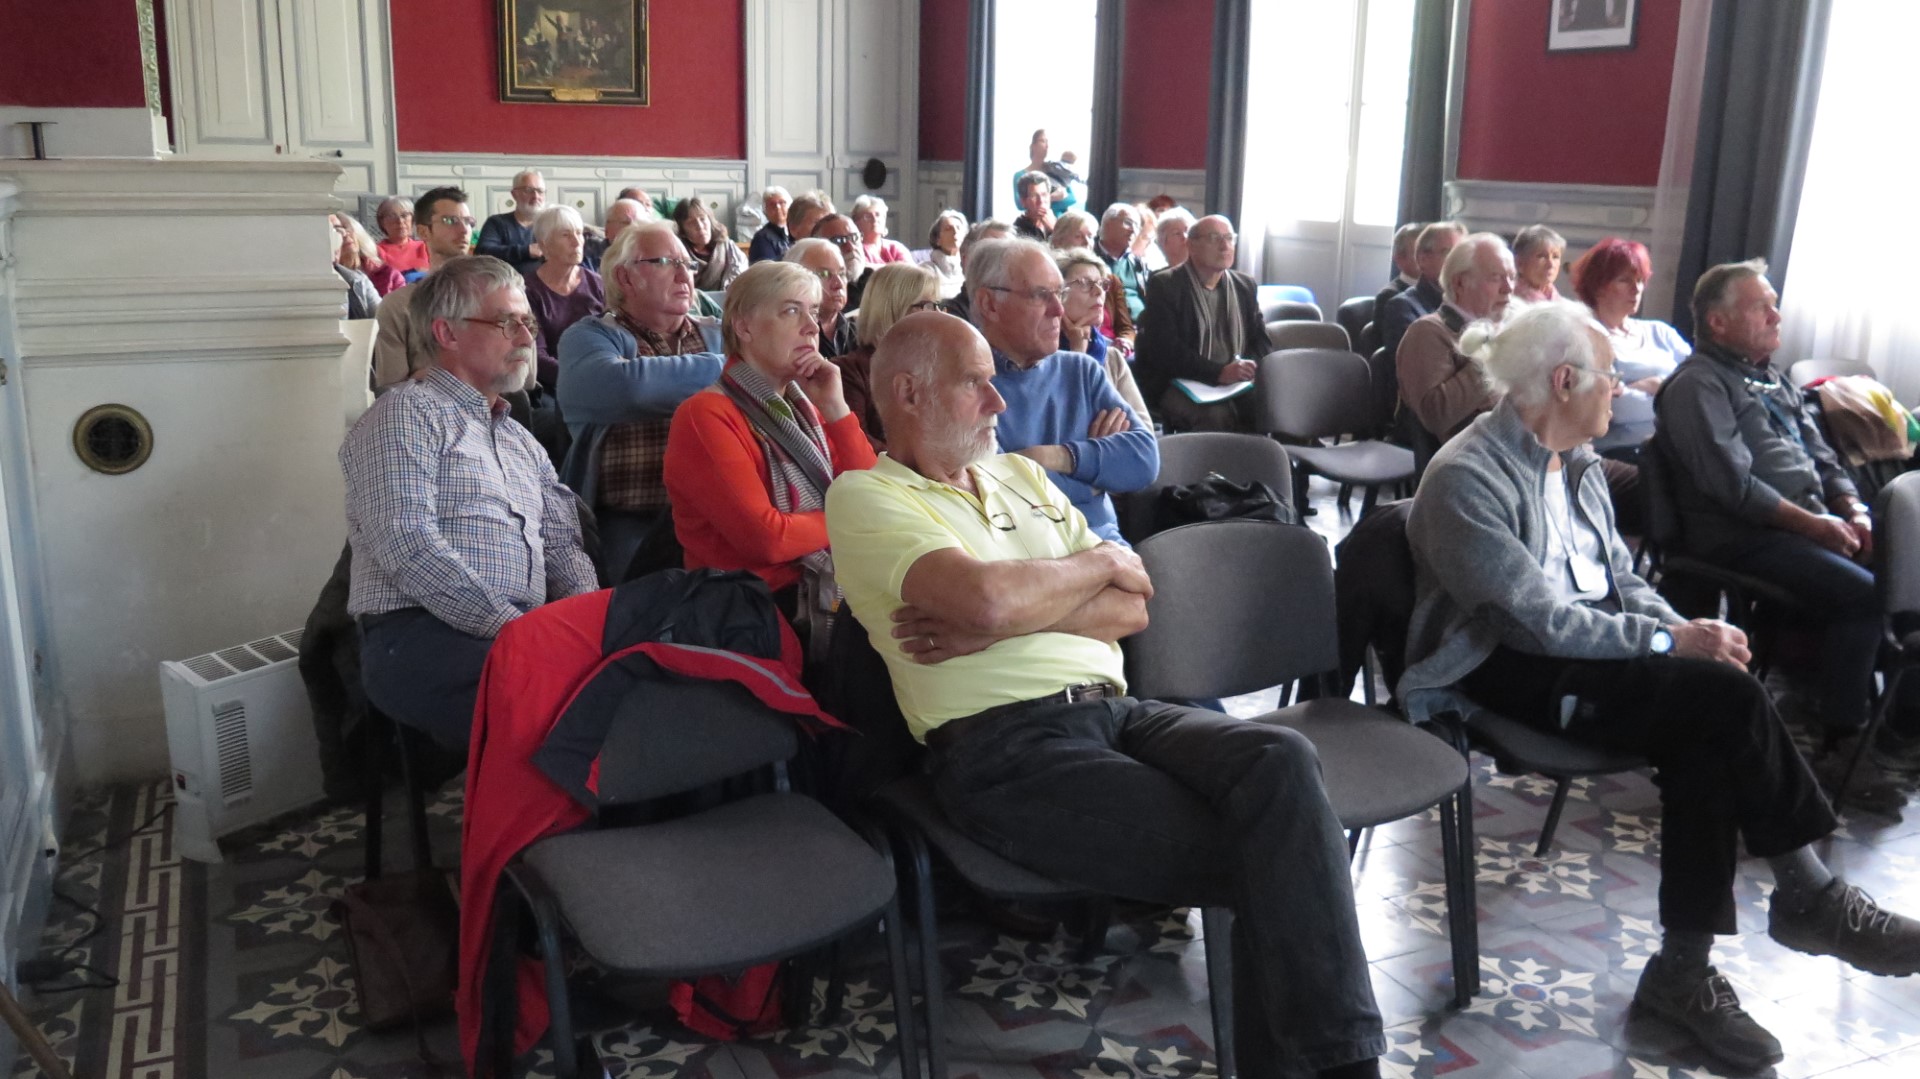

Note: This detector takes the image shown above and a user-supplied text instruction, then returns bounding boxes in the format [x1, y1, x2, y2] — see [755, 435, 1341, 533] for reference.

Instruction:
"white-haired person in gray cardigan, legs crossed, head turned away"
[1400, 301, 1920, 1069]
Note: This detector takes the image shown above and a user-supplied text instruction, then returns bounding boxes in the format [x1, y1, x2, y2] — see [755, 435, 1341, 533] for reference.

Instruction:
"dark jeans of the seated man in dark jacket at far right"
[1709, 528, 1884, 733]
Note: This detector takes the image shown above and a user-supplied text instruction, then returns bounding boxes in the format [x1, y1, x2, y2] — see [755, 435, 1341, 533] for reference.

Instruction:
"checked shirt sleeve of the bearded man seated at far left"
[340, 396, 529, 637]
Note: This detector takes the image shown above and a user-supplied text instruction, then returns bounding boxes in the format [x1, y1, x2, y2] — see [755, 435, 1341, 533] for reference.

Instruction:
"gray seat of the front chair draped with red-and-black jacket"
[524, 793, 893, 977]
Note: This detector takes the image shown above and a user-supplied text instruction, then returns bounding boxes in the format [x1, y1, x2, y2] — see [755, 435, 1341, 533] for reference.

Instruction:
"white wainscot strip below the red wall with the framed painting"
[391, 154, 749, 225]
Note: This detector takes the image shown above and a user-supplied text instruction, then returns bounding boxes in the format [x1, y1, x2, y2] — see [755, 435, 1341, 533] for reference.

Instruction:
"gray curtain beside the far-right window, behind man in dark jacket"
[1672, 0, 1827, 338]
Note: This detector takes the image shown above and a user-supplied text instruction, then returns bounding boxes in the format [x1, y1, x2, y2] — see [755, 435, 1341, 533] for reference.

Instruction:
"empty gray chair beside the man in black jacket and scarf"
[1254, 348, 1415, 513]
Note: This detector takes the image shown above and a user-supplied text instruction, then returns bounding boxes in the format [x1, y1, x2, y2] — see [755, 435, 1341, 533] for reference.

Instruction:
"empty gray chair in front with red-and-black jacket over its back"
[491, 682, 920, 1079]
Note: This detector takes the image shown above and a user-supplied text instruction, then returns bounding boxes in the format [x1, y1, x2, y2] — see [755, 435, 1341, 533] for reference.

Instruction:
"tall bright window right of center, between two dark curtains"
[1238, 0, 1415, 297]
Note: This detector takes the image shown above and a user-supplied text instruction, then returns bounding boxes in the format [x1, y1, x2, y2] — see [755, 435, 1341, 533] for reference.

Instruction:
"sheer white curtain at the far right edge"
[1776, 4, 1920, 403]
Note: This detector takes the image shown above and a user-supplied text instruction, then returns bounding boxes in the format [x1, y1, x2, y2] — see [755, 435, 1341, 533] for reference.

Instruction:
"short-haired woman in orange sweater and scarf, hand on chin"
[664, 263, 876, 639]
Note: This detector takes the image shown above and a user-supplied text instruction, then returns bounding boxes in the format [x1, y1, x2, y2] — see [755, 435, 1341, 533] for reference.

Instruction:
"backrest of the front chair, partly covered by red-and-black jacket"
[599, 680, 801, 806]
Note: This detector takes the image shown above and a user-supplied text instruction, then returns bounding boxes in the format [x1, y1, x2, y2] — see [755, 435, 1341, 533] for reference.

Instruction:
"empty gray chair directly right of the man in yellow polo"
[1123, 522, 1480, 1006]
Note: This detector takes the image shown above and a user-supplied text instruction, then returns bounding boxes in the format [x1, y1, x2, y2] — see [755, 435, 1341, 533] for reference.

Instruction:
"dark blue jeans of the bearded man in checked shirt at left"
[361, 607, 493, 753]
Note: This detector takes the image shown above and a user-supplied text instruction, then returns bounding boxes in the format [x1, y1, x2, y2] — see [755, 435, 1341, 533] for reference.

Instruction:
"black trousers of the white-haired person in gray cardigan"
[1461, 647, 1836, 933]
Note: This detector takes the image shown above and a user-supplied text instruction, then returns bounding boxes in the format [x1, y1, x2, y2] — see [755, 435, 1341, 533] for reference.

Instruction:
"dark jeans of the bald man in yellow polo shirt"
[927, 697, 1386, 1079]
